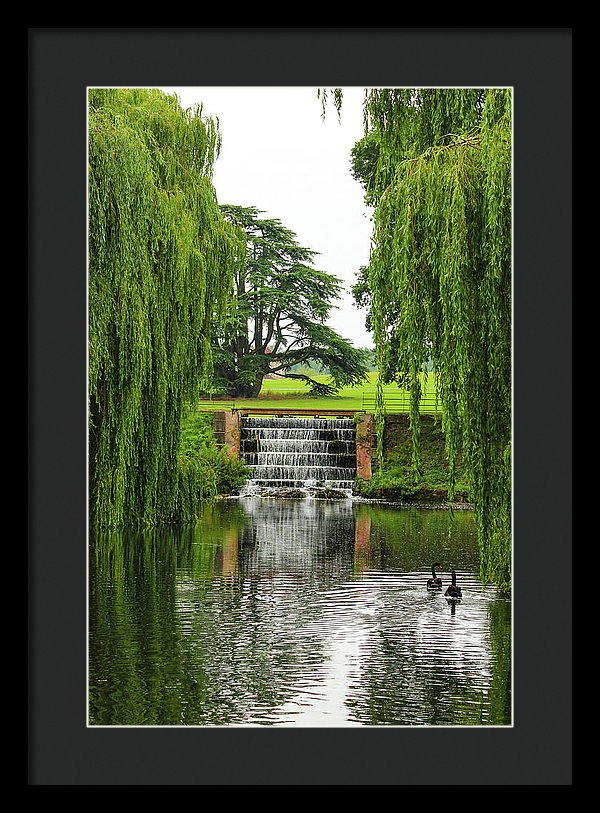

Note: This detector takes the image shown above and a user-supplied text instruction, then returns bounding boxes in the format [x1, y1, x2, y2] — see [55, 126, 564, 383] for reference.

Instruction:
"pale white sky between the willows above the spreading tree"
[161, 87, 373, 347]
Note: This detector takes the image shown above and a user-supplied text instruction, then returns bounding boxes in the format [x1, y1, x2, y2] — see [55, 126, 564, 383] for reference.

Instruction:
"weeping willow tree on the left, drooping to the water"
[88, 89, 244, 526]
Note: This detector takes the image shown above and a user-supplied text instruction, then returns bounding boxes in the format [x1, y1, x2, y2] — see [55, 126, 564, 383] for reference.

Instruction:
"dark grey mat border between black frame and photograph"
[28, 28, 573, 786]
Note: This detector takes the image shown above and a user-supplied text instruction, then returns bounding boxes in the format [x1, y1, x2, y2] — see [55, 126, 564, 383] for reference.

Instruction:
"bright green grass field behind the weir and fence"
[198, 373, 439, 413]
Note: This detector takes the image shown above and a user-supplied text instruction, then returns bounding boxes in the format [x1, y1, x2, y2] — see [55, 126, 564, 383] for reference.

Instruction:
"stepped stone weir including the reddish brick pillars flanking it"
[213, 411, 372, 494]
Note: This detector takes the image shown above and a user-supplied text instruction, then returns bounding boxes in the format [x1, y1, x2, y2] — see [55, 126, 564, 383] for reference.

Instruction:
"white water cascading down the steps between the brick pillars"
[240, 416, 356, 493]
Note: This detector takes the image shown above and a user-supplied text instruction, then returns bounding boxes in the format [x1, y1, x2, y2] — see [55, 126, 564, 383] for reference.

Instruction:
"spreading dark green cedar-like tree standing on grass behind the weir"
[213, 206, 369, 397]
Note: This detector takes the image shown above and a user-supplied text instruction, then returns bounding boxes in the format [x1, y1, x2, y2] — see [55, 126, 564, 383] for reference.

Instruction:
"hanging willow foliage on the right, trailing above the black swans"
[356, 89, 512, 590]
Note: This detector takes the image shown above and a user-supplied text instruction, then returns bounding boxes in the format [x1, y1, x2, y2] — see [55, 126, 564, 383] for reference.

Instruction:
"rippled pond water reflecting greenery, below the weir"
[89, 497, 512, 728]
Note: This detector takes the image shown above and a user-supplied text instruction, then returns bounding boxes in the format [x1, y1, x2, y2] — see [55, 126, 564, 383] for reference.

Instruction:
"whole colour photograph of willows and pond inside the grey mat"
[88, 87, 513, 728]
